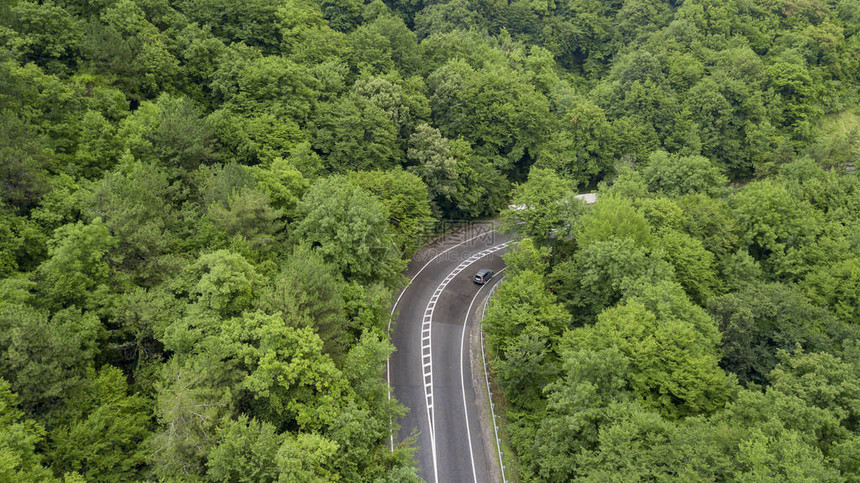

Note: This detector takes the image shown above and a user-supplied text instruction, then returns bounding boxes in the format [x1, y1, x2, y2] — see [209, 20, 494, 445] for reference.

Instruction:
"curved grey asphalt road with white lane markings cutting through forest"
[389, 225, 510, 483]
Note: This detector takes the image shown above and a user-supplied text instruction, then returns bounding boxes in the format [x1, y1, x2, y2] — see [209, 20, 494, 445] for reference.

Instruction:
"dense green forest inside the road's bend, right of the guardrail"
[484, 157, 860, 482]
